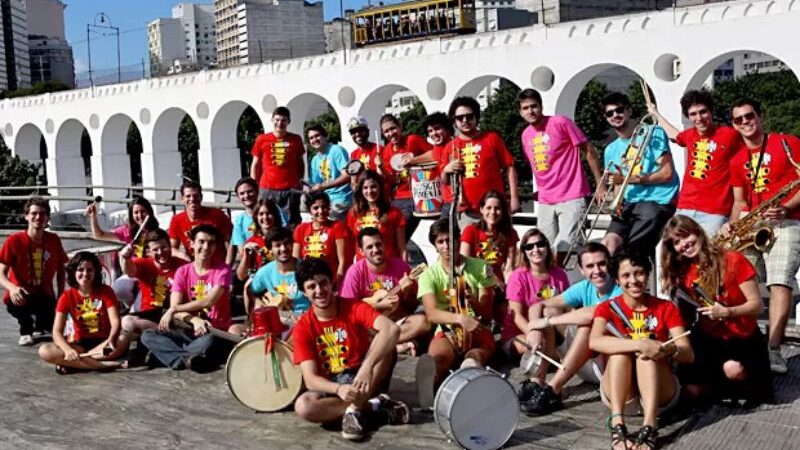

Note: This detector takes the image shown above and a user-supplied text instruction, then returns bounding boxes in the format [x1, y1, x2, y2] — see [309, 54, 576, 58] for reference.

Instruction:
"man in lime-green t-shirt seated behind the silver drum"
[417, 219, 495, 408]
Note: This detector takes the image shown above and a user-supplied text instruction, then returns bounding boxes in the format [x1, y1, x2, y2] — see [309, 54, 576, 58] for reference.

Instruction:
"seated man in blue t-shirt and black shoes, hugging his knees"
[515, 242, 622, 415]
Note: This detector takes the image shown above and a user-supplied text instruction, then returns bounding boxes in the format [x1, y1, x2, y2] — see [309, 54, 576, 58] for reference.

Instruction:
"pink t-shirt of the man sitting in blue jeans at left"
[172, 263, 232, 331]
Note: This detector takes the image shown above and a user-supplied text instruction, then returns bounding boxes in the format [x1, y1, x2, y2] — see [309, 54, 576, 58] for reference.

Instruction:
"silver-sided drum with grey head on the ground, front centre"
[433, 367, 519, 450]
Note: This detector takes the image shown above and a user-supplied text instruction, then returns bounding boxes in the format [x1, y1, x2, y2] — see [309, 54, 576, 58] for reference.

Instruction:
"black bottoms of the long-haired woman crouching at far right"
[678, 328, 773, 402]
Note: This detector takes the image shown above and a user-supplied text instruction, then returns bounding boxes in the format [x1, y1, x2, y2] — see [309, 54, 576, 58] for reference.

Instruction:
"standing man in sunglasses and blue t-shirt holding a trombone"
[602, 92, 679, 256]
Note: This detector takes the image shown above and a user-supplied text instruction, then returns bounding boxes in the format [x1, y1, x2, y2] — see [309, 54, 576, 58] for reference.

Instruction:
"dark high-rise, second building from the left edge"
[25, 0, 75, 87]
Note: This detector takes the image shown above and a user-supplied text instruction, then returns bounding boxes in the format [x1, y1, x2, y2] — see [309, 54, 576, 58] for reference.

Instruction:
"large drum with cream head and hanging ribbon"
[225, 336, 303, 412]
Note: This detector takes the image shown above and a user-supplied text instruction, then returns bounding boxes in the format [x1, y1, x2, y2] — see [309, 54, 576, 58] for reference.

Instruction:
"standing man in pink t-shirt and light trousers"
[517, 89, 605, 263]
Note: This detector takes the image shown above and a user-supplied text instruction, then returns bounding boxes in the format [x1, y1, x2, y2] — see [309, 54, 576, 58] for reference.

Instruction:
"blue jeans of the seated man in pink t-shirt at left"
[141, 330, 214, 369]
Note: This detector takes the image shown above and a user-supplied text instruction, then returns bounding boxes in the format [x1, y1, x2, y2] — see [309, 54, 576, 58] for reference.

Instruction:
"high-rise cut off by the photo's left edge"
[0, 0, 31, 91]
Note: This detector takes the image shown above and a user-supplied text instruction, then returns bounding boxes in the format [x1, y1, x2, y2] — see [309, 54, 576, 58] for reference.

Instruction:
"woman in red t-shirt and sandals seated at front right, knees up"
[589, 250, 694, 450]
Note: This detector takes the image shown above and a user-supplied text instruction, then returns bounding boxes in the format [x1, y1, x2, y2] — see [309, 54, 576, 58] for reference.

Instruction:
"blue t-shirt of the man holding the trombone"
[603, 126, 680, 205]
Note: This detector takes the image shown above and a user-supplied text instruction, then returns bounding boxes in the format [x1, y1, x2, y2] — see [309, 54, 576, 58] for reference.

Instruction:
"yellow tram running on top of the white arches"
[351, 0, 475, 47]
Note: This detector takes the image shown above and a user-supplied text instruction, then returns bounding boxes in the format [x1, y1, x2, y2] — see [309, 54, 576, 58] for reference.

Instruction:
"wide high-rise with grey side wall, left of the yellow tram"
[214, 0, 325, 67]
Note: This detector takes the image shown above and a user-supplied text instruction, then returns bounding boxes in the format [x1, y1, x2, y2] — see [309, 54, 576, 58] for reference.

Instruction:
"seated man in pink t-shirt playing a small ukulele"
[339, 227, 430, 353]
